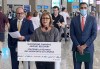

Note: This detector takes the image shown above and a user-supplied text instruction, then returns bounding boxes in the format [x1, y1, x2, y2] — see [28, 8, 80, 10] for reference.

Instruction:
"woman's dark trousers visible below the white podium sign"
[35, 62, 55, 69]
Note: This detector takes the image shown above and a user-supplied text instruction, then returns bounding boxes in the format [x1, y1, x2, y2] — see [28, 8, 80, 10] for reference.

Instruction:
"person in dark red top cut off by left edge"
[0, 6, 9, 55]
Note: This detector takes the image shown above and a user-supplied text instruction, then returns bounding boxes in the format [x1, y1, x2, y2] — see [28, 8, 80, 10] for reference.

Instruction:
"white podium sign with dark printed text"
[18, 42, 61, 62]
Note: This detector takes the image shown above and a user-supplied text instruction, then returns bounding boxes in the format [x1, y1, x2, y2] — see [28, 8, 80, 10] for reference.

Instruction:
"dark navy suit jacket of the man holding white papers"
[8, 18, 34, 47]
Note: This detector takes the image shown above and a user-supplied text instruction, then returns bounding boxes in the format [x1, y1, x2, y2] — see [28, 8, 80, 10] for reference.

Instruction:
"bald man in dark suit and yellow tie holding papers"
[8, 7, 34, 69]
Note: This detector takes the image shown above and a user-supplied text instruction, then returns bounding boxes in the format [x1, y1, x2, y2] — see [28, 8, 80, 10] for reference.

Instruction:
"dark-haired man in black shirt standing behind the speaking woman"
[52, 6, 65, 41]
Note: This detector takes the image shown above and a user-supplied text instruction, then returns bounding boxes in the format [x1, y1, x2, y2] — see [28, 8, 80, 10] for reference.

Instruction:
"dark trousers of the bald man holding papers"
[9, 47, 19, 69]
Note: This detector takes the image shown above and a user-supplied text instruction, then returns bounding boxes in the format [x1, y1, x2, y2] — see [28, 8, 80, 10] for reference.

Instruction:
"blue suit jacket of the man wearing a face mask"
[70, 15, 97, 51]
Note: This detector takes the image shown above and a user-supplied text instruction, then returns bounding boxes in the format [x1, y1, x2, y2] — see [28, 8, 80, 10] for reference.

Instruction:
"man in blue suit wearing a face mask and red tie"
[70, 2, 97, 69]
